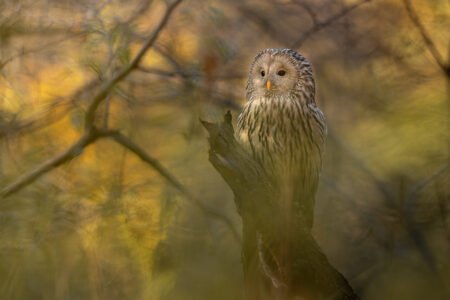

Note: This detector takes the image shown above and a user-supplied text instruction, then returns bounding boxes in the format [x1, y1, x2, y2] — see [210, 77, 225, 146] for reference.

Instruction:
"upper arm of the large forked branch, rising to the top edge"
[85, 0, 182, 128]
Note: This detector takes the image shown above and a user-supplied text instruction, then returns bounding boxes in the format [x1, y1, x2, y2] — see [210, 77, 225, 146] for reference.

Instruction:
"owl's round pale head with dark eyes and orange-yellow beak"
[247, 49, 315, 102]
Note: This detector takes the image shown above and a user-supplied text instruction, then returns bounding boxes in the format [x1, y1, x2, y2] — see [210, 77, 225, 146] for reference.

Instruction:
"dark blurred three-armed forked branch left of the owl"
[0, 0, 240, 242]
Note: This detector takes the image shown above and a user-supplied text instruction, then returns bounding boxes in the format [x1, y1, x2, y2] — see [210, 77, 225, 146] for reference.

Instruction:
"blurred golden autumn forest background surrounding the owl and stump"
[0, 0, 450, 300]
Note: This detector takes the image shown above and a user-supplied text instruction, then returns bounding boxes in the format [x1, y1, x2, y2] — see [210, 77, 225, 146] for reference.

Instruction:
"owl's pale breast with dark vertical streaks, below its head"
[237, 95, 326, 205]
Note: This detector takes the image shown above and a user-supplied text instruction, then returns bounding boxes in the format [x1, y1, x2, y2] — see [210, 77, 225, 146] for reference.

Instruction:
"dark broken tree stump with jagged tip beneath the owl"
[202, 112, 359, 300]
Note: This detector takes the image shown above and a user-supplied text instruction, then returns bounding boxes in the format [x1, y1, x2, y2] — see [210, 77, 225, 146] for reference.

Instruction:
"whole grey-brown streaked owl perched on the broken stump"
[237, 49, 327, 228]
